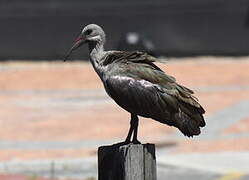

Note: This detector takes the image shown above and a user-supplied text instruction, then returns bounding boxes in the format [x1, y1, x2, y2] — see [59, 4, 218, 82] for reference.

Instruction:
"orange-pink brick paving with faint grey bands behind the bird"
[0, 57, 249, 179]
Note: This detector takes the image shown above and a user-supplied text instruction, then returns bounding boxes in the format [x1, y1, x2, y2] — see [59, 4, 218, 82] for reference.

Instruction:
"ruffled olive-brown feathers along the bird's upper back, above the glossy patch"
[105, 51, 198, 102]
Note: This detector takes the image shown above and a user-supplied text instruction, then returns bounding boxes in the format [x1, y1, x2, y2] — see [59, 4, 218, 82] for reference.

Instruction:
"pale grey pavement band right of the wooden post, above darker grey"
[157, 151, 249, 174]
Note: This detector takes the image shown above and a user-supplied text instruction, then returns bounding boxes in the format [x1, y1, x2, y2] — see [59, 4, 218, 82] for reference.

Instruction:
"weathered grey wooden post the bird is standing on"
[98, 143, 157, 180]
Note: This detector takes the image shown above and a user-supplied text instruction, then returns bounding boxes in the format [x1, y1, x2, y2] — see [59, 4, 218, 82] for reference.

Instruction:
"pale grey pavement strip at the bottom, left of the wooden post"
[0, 157, 97, 179]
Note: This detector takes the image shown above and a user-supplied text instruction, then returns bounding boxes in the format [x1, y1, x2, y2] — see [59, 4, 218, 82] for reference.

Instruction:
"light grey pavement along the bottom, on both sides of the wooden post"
[0, 151, 249, 180]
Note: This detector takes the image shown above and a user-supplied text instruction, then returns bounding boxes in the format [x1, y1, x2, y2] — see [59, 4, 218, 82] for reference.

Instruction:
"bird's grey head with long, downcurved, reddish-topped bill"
[64, 24, 105, 61]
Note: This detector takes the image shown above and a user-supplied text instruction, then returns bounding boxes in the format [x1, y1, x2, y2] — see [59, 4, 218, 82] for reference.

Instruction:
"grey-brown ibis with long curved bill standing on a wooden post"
[64, 24, 206, 144]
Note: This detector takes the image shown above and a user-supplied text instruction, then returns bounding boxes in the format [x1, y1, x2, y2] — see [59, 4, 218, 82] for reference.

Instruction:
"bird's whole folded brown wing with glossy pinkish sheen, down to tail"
[104, 50, 205, 136]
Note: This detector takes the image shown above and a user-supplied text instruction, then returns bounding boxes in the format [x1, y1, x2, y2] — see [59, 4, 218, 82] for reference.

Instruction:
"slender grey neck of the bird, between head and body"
[88, 41, 105, 76]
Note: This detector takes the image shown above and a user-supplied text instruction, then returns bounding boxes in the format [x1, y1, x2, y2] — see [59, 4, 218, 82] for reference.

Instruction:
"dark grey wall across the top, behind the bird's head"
[0, 0, 249, 59]
